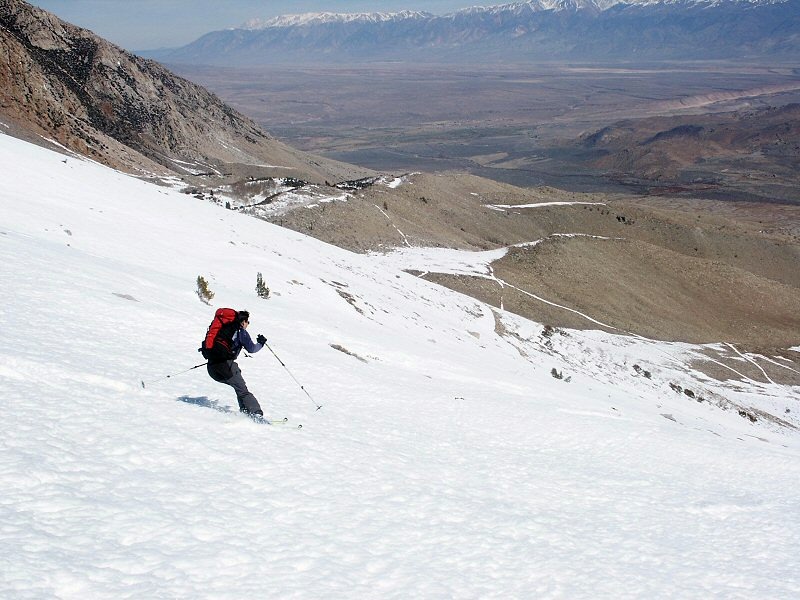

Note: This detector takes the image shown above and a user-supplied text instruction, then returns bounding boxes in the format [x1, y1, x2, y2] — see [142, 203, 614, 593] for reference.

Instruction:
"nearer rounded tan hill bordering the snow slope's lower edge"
[495, 237, 800, 348]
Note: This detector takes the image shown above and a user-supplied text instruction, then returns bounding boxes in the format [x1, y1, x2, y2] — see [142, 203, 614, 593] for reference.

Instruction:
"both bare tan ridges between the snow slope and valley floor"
[268, 174, 800, 349]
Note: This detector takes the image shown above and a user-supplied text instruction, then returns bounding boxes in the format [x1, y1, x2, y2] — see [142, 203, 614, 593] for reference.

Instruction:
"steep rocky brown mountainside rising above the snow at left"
[0, 0, 364, 181]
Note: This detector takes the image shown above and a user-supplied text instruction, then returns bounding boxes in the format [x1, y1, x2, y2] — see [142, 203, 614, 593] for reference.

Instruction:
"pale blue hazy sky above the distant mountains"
[29, 0, 482, 50]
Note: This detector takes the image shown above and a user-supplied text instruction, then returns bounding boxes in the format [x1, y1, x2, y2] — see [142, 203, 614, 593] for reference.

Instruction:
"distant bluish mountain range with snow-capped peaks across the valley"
[147, 0, 800, 65]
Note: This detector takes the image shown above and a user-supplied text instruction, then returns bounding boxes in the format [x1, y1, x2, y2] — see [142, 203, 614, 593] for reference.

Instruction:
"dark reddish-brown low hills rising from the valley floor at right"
[582, 104, 800, 203]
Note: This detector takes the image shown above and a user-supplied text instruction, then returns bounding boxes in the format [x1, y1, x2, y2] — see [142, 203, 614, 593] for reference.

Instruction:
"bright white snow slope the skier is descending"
[0, 135, 800, 599]
